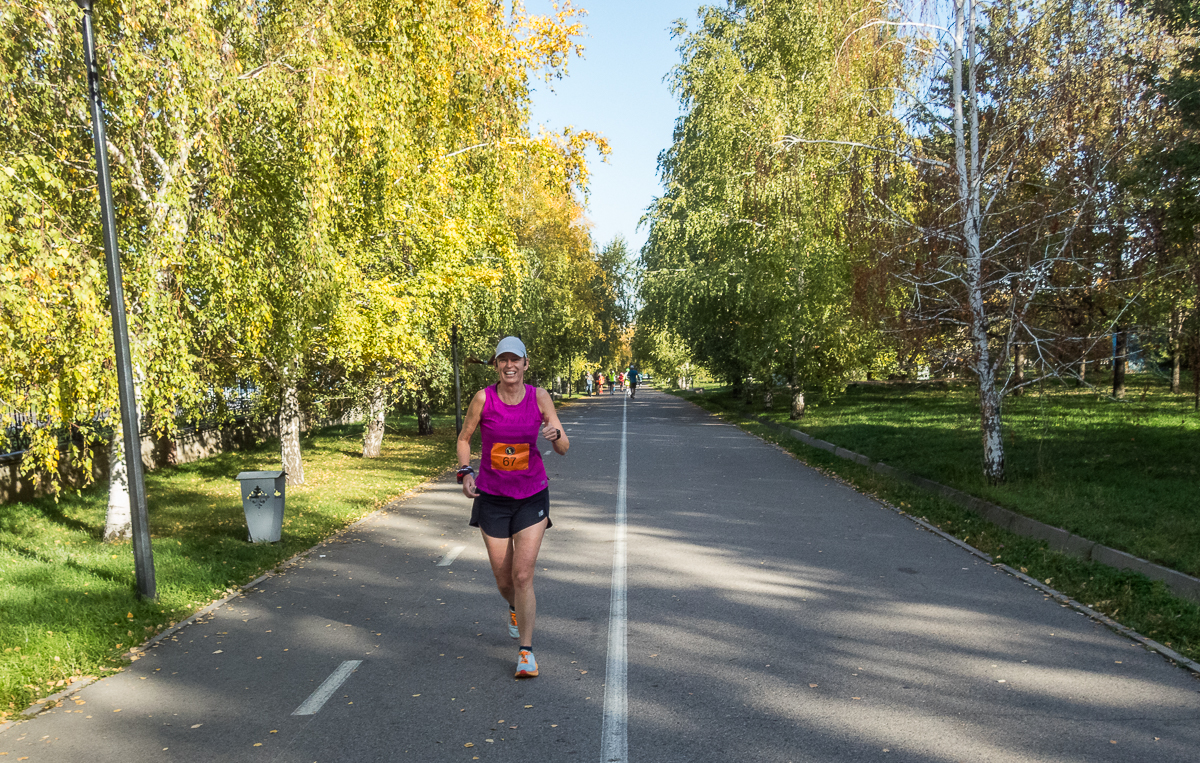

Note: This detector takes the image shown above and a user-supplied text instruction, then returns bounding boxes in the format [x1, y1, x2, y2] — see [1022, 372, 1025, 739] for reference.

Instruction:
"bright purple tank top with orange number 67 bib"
[475, 384, 546, 498]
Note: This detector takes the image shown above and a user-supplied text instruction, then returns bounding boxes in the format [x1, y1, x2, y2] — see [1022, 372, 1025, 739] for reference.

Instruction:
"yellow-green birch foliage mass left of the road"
[0, 0, 607, 484]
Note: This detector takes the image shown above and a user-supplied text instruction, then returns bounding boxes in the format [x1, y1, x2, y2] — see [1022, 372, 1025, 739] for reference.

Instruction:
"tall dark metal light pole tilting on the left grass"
[76, 0, 157, 599]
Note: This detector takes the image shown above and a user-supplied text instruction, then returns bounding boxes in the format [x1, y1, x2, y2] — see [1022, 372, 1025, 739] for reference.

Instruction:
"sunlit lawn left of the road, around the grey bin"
[0, 416, 455, 721]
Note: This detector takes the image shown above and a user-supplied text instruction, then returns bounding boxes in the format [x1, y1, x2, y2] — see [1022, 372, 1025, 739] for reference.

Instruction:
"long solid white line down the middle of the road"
[600, 397, 629, 763]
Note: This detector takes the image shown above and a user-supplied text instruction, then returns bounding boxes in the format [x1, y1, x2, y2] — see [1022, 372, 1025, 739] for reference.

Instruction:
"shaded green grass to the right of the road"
[679, 385, 1200, 660]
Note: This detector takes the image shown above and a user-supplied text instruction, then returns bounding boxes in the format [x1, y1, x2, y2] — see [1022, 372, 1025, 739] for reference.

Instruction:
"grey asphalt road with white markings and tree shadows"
[0, 390, 1200, 763]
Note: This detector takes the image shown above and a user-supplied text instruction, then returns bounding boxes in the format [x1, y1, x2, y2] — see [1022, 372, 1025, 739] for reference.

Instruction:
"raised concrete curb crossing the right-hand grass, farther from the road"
[745, 416, 1200, 602]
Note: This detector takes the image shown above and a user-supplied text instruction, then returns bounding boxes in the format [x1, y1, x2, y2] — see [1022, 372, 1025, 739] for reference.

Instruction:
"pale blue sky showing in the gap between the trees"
[526, 0, 712, 257]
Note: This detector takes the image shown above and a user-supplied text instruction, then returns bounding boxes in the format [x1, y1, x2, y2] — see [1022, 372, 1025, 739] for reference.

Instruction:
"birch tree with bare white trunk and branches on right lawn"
[849, 0, 1176, 483]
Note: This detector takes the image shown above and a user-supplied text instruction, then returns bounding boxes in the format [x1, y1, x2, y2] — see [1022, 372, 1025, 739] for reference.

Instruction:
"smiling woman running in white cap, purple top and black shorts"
[458, 336, 571, 678]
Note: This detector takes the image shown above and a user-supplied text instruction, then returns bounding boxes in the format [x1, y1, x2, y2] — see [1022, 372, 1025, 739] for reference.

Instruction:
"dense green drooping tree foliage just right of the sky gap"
[638, 2, 898, 391]
